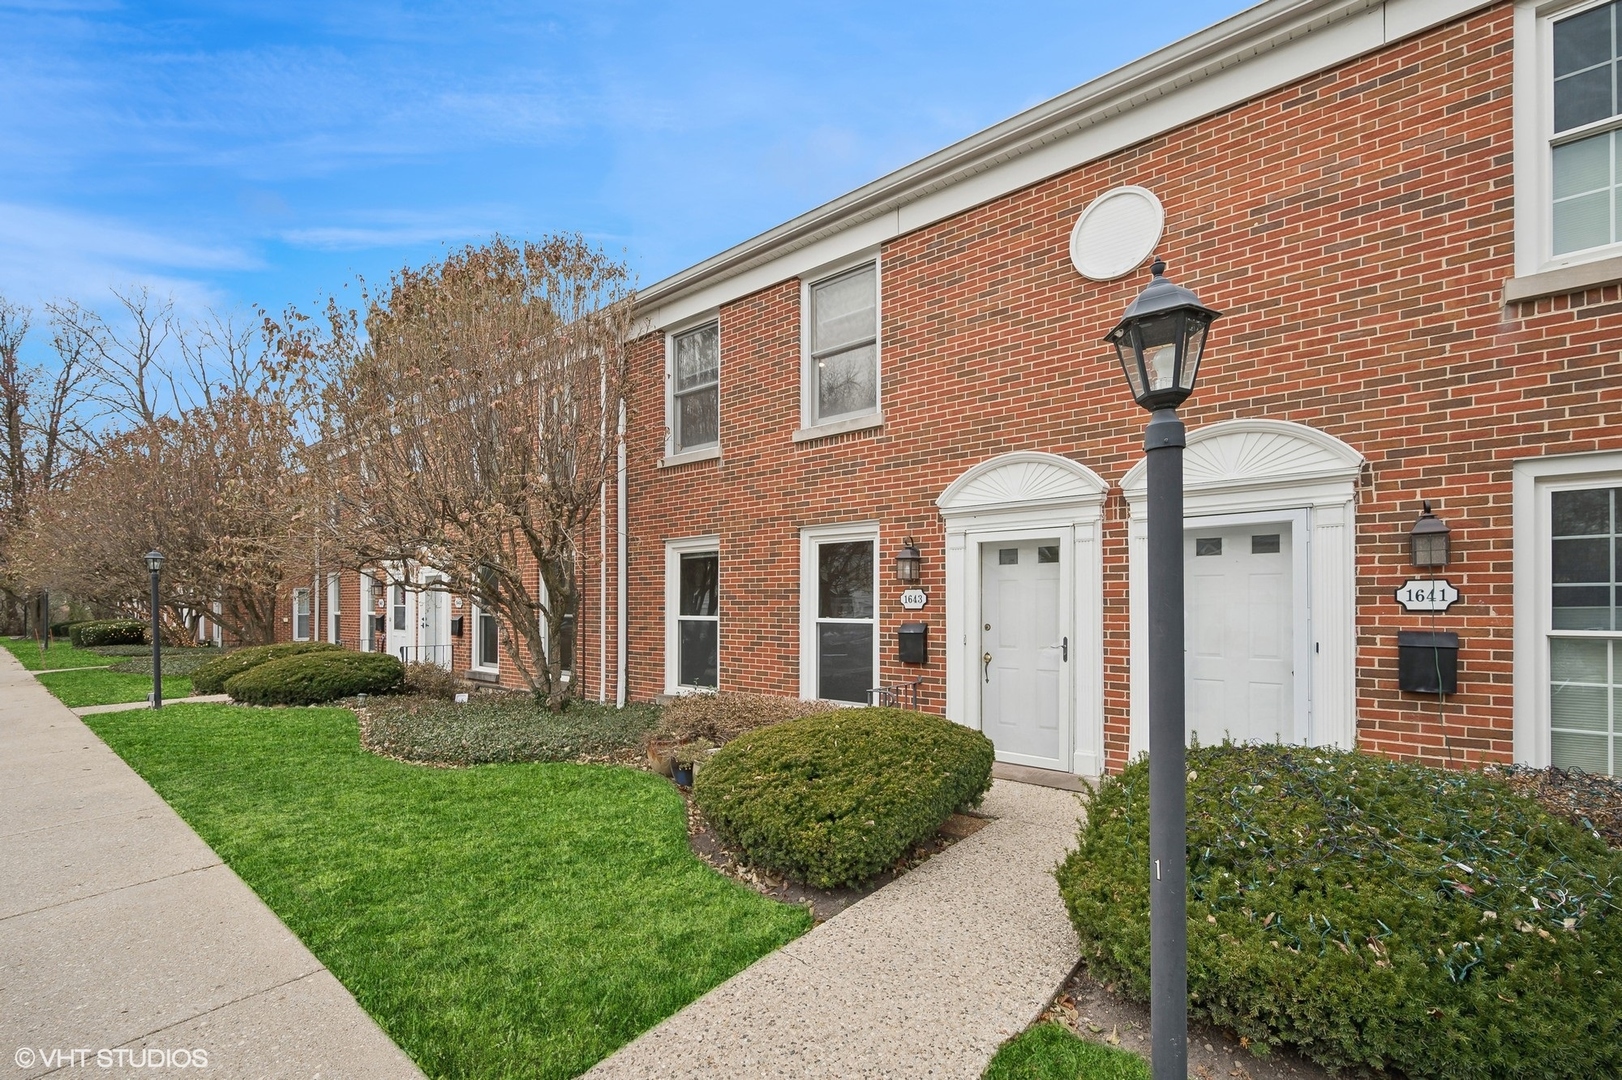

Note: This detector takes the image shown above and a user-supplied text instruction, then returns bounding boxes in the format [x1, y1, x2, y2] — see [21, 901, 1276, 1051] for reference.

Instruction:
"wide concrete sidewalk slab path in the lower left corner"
[0, 650, 422, 1080]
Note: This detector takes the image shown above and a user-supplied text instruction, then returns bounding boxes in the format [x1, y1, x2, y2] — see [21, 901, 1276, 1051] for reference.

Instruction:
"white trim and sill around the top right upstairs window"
[1504, 0, 1622, 288]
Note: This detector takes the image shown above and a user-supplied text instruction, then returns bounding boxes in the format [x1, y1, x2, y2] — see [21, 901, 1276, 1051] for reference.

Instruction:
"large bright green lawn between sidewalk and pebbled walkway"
[88, 705, 809, 1080]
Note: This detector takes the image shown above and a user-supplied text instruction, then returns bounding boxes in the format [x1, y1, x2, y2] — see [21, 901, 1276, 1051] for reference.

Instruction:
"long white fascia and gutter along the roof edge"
[639, 0, 1494, 328]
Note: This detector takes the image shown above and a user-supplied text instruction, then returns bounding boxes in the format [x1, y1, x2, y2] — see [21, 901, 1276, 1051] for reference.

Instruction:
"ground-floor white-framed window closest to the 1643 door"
[800, 525, 878, 702]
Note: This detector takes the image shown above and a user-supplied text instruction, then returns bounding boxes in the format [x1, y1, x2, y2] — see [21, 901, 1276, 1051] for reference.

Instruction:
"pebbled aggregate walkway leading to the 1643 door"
[586, 780, 1080, 1080]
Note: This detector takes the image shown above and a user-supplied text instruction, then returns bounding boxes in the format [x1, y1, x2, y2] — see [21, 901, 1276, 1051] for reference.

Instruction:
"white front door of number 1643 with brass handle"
[975, 537, 1071, 770]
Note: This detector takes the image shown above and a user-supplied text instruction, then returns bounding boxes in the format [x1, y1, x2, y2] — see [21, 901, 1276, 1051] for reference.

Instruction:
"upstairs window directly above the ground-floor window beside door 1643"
[806, 263, 879, 428]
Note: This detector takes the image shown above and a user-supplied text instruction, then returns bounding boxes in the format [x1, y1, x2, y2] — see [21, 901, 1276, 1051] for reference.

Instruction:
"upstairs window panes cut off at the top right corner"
[1551, 2, 1622, 256]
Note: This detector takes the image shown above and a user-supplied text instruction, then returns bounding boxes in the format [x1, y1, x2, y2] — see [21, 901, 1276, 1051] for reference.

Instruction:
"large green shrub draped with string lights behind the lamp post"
[1058, 746, 1622, 1080]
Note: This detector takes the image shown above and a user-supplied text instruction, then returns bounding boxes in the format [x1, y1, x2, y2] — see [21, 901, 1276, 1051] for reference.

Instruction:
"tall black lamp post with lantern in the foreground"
[1105, 259, 1218, 1080]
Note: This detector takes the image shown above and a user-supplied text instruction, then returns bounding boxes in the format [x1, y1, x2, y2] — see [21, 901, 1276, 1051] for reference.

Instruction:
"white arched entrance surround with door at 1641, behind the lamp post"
[1121, 420, 1364, 756]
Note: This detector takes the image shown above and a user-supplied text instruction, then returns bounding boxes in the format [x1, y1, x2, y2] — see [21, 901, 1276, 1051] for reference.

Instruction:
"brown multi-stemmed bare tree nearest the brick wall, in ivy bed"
[295, 235, 631, 709]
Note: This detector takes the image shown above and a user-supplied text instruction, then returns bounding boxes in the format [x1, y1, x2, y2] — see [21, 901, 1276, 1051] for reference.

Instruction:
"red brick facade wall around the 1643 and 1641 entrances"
[603, 5, 1622, 767]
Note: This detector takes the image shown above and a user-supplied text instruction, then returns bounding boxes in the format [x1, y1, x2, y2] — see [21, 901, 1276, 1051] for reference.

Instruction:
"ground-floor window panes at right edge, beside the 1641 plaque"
[1549, 486, 1622, 777]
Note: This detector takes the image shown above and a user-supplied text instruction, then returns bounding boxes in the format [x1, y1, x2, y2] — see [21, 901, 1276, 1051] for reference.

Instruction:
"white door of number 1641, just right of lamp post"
[1184, 521, 1302, 746]
